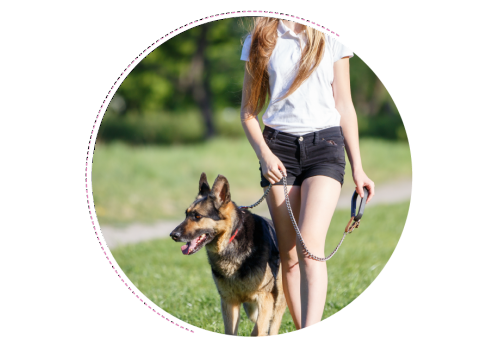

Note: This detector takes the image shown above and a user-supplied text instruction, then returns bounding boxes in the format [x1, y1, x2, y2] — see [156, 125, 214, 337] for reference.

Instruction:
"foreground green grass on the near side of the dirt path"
[112, 201, 411, 337]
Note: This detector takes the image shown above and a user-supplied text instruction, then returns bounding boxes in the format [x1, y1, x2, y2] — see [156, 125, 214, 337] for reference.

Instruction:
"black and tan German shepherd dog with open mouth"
[170, 173, 286, 338]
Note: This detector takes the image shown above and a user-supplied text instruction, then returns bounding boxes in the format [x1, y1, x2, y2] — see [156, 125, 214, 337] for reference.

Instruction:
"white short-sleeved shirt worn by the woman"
[240, 20, 354, 136]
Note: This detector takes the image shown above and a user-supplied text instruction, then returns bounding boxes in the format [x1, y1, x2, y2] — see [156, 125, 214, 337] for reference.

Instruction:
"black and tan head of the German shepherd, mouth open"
[170, 173, 234, 255]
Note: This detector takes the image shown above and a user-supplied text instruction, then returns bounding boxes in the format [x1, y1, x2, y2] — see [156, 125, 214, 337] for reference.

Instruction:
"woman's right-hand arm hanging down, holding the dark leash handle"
[332, 57, 374, 203]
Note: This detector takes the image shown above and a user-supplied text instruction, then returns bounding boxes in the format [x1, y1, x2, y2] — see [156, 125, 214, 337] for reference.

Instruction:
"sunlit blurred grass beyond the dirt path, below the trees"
[91, 137, 413, 225]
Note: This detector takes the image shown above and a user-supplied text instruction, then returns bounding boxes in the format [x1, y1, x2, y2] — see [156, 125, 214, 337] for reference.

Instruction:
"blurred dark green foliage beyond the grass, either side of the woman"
[103, 18, 408, 144]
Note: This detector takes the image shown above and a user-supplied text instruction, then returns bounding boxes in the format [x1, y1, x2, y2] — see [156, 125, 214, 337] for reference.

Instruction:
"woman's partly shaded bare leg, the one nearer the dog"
[265, 186, 301, 332]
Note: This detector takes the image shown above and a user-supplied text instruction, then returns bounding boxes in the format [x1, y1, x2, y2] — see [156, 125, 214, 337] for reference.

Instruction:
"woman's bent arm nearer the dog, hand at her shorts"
[240, 68, 287, 184]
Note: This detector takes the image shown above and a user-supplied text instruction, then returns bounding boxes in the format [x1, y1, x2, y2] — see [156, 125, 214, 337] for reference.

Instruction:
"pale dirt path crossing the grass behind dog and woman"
[100, 178, 414, 249]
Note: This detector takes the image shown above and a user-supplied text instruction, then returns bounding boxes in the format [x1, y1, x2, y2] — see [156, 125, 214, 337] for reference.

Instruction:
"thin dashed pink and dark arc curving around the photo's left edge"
[86, 11, 341, 335]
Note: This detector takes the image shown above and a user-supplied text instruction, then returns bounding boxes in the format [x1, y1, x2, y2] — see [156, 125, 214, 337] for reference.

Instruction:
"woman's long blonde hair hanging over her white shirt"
[245, 17, 325, 115]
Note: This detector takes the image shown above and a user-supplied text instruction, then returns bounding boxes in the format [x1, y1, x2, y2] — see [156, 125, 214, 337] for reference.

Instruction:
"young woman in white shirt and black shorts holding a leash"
[241, 17, 374, 331]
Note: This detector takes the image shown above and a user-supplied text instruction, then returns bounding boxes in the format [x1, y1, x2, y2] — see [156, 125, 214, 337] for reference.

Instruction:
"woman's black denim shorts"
[259, 126, 345, 187]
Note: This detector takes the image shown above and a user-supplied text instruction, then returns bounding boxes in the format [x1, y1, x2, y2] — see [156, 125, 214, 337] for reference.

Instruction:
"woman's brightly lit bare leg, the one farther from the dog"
[298, 176, 341, 330]
